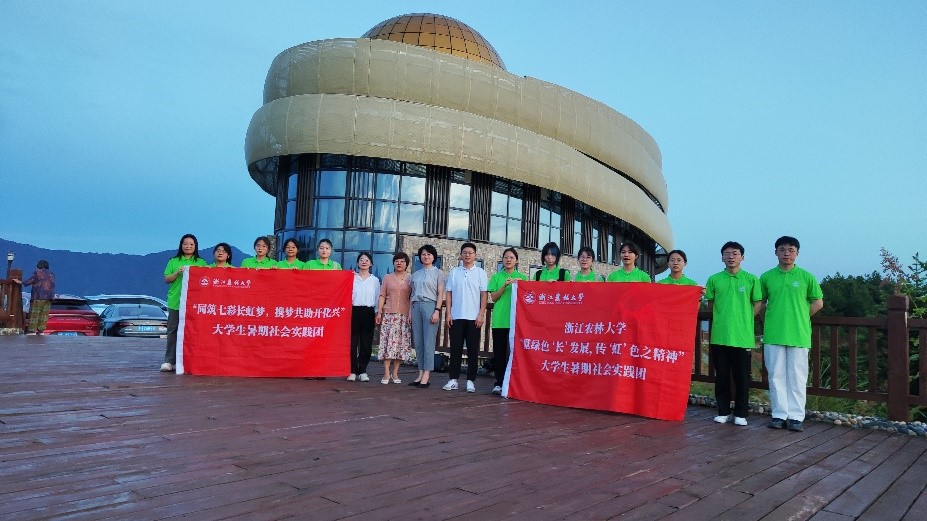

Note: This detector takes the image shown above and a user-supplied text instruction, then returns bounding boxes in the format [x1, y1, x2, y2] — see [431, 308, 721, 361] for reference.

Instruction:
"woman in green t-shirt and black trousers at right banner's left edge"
[488, 248, 528, 394]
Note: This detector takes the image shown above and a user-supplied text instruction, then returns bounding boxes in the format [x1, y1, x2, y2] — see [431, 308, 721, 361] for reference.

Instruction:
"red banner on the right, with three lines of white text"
[503, 281, 701, 420]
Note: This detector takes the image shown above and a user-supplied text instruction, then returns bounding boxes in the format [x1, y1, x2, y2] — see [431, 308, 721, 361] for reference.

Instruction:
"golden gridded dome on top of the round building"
[362, 13, 505, 70]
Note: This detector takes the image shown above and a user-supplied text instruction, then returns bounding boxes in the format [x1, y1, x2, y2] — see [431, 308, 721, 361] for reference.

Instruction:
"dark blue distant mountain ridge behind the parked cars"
[0, 239, 250, 298]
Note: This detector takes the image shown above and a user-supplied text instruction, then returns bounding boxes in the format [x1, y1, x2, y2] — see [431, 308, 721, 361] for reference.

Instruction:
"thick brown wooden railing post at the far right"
[886, 295, 910, 422]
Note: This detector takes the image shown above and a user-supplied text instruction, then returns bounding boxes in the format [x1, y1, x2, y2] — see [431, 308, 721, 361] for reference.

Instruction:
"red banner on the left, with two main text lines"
[177, 267, 354, 377]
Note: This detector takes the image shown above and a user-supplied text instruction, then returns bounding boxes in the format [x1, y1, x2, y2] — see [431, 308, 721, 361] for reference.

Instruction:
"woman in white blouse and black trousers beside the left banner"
[348, 252, 380, 382]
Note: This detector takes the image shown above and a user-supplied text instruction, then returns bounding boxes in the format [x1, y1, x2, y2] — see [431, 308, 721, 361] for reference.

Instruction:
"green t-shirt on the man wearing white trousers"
[760, 266, 824, 348]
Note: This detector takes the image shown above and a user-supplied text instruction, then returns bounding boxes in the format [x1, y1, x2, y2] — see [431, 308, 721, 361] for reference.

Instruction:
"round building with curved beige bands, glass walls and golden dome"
[245, 14, 672, 274]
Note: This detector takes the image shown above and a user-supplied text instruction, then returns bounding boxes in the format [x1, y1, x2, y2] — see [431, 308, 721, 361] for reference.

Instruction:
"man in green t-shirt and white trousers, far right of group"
[760, 235, 824, 432]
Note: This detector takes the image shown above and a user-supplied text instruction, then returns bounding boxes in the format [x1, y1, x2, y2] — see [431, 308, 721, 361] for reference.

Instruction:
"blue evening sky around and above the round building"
[0, 0, 927, 282]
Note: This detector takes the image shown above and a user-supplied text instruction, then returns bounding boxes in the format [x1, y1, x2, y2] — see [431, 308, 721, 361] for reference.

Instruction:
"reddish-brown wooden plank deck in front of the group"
[0, 336, 927, 521]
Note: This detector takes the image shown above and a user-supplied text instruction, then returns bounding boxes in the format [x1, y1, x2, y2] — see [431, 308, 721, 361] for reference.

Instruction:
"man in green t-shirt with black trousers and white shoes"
[705, 241, 763, 425]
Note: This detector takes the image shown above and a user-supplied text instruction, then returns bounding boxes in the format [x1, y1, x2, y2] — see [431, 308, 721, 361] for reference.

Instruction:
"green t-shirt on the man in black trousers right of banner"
[705, 270, 763, 349]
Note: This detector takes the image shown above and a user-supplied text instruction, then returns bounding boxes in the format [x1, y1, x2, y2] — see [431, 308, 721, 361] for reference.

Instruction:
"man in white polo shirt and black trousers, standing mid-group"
[444, 242, 490, 393]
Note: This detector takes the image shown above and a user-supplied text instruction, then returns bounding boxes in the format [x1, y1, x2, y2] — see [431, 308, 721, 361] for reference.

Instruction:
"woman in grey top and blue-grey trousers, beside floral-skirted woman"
[409, 244, 447, 389]
